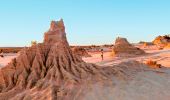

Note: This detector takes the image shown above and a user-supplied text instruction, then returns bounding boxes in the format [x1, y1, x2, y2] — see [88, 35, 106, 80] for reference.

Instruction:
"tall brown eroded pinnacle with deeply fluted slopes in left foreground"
[0, 20, 109, 100]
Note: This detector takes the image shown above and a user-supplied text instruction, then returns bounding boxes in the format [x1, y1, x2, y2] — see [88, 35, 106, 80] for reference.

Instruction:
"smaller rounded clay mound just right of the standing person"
[113, 37, 145, 55]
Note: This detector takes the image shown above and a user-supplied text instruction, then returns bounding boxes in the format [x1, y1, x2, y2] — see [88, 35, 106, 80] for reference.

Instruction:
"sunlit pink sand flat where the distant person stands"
[83, 50, 170, 67]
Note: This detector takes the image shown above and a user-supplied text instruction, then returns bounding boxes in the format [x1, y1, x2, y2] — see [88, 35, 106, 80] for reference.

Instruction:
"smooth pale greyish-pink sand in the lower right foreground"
[83, 70, 170, 100]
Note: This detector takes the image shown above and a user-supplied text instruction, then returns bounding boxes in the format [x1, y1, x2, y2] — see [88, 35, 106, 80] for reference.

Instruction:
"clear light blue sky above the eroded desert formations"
[0, 0, 170, 47]
